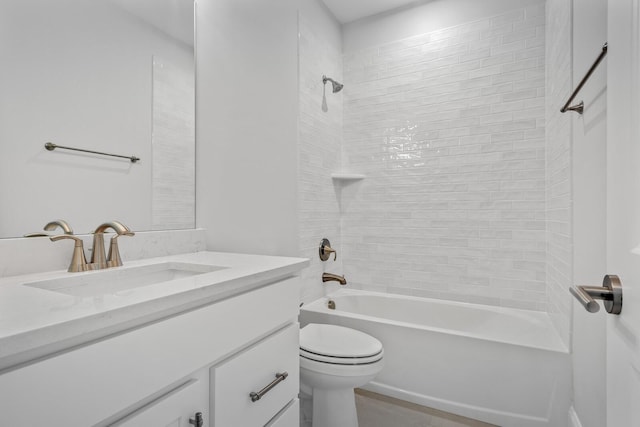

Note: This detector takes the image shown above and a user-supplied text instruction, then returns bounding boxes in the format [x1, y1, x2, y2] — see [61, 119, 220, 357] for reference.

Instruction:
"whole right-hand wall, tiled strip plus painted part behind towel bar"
[547, 0, 607, 427]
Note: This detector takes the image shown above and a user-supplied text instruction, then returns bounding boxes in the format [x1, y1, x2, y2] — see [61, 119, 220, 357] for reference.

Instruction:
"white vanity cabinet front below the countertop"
[0, 277, 299, 427]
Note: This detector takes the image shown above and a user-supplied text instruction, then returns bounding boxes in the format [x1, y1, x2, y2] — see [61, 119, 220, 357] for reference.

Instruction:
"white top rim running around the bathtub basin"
[300, 289, 570, 354]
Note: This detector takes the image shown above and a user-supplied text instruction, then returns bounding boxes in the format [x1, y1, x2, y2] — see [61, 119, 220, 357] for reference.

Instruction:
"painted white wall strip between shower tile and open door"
[567, 0, 608, 427]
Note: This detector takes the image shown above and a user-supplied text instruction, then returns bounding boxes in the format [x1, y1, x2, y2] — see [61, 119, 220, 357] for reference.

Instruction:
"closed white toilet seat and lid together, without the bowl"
[300, 323, 384, 366]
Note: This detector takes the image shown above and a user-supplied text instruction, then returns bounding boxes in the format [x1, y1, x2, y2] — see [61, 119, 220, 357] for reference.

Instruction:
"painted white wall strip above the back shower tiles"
[343, 0, 540, 53]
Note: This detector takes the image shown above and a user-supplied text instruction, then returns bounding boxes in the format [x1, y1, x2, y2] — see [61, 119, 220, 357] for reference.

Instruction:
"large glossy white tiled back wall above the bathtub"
[342, 4, 547, 310]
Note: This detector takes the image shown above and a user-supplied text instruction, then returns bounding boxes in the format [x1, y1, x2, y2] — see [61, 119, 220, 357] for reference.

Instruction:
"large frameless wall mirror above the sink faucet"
[0, 0, 195, 238]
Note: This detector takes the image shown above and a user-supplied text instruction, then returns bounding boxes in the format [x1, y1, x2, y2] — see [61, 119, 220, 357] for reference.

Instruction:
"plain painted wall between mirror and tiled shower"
[196, 0, 298, 255]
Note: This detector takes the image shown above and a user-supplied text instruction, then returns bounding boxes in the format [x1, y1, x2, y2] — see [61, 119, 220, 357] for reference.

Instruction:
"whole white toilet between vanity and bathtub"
[300, 323, 384, 427]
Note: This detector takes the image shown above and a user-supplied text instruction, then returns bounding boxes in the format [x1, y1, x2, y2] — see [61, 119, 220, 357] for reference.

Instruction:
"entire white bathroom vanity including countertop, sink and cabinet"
[0, 252, 308, 427]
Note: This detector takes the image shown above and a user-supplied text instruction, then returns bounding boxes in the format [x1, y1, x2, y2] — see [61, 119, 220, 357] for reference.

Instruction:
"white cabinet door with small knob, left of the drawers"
[111, 370, 209, 427]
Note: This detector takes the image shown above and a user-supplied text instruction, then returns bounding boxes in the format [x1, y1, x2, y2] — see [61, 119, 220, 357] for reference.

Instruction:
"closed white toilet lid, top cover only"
[300, 323, 382, 358]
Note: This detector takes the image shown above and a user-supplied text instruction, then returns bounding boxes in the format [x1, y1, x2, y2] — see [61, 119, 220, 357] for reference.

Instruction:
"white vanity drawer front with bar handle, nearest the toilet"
[210, 324, 299, 427]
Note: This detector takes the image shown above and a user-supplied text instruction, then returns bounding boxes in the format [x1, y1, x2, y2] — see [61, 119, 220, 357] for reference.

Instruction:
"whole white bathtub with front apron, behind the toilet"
[300, 290, 571, 427]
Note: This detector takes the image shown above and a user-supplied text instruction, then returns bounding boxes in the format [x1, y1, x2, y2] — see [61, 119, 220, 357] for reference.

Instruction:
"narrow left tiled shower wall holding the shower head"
[298, 9, 342, 302]
